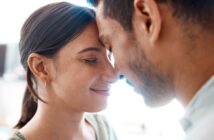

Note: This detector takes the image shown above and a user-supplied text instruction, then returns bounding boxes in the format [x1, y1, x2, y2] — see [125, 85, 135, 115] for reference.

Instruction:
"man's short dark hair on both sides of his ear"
[88, 0, 214, 32]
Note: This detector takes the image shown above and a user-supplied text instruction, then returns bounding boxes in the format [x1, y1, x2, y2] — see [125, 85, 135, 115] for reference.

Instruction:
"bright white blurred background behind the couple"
[0, 0, 184, 140]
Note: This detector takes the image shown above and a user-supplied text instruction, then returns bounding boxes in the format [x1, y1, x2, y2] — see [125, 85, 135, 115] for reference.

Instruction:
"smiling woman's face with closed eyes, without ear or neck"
[49, 24, 116, 112]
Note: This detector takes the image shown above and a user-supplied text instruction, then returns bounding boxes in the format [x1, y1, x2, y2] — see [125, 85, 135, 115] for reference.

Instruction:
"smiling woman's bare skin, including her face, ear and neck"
[20, 23, 117, 140]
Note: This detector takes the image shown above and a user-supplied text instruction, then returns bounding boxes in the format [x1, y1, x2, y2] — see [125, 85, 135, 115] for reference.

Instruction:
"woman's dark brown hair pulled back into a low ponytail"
[15, 2, 95, 128]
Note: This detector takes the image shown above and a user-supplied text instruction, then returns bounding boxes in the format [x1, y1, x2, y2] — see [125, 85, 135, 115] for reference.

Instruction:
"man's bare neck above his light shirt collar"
[175, 31, 214, 106]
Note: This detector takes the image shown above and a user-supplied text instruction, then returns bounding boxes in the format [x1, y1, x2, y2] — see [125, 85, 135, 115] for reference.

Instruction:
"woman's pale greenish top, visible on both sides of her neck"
[8, 114, 118, 140]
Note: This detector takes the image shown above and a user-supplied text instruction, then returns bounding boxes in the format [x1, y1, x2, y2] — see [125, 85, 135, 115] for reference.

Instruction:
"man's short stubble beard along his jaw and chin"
[128, 42, 175, 107]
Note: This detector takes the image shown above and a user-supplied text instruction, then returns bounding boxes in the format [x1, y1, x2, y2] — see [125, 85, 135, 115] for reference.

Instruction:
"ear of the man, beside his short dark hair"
[134, 0, 161, 42]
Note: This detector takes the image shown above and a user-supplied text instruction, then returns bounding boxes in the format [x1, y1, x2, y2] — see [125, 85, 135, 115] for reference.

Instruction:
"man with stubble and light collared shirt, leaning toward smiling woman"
[88, 0, 214, 140]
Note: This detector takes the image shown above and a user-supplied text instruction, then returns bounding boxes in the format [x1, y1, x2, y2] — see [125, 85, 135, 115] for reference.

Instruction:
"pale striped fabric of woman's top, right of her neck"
[86, 114, 117, 140]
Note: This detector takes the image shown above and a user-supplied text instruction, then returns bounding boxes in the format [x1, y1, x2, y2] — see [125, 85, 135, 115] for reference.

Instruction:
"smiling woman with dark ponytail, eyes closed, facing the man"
[10, 2, 116, 140]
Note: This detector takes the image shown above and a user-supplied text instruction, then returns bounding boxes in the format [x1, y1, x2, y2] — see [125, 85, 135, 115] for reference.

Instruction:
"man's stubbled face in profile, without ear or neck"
[97, 2, 174, 106]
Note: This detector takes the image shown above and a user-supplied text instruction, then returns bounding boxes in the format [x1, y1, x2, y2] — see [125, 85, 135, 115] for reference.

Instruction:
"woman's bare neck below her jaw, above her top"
[20, 106, 95, 140]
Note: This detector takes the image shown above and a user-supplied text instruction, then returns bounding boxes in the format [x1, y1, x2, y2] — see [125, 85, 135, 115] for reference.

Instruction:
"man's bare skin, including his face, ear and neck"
[96, 0, 214, 107]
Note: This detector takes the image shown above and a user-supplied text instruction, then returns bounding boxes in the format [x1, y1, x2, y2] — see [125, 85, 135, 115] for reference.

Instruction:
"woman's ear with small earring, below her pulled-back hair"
[28, 53, 50, 84]
